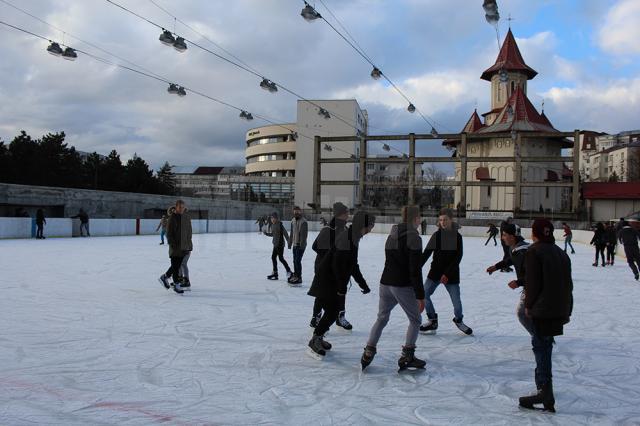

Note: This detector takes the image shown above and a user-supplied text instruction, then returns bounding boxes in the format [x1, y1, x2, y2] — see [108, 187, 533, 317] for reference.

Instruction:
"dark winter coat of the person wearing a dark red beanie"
[524, 241, 573, 336]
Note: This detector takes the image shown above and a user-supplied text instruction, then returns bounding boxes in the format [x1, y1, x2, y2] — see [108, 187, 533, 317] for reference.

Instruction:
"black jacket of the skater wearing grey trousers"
[380, 223, 424, 300]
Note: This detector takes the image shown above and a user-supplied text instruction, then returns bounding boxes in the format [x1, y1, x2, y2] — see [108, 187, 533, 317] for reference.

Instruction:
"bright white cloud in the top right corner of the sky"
[598, 0, 640, 55]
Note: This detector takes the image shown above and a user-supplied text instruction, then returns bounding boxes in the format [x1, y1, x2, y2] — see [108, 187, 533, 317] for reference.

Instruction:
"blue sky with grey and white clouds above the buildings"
[0, 0, 640, 167]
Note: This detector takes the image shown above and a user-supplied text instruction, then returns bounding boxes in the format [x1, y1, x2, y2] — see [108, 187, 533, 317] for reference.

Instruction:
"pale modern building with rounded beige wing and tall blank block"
[245, 99, 368, 208]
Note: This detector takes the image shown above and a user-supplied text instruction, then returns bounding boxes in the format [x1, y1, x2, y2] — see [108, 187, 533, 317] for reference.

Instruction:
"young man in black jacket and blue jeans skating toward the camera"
[420, 209, 470, 335]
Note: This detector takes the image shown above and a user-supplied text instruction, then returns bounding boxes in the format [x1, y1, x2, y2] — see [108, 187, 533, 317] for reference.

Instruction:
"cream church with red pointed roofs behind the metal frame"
[443, 30, 573, 211]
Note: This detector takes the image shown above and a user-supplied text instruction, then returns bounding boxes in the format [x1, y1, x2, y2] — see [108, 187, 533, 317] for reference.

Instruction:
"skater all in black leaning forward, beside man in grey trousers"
[308, 211, 376, 356]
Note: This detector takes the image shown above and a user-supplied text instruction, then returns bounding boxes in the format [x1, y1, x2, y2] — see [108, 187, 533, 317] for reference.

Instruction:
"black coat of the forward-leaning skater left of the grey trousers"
[307, 227, 369, 299]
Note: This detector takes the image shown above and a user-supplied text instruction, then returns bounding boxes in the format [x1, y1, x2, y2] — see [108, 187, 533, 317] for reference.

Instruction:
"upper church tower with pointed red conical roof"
[480, 28, 538, 126]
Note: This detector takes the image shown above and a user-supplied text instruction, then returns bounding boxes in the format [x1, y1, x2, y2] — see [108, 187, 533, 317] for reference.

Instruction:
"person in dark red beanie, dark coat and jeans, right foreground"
[519, 219, 573, 412]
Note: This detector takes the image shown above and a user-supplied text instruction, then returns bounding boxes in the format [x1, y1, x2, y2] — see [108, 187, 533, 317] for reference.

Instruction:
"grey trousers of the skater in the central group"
[367, 284, 422, 347]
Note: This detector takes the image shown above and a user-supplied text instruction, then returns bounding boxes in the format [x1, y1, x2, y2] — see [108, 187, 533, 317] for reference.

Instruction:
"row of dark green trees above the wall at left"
[0, 130, 175, 195]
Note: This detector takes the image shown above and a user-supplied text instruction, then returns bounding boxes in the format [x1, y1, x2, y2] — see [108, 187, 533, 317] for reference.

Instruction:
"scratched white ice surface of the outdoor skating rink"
[0, 233, 640, 425]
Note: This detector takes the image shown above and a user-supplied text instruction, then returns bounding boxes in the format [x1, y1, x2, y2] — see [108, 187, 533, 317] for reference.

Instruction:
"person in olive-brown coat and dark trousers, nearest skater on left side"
[159, 200, 193, 294]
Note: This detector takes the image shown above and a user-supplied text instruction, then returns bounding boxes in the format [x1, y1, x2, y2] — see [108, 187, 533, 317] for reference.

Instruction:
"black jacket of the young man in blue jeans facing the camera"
[422, 229, 462, 284]
